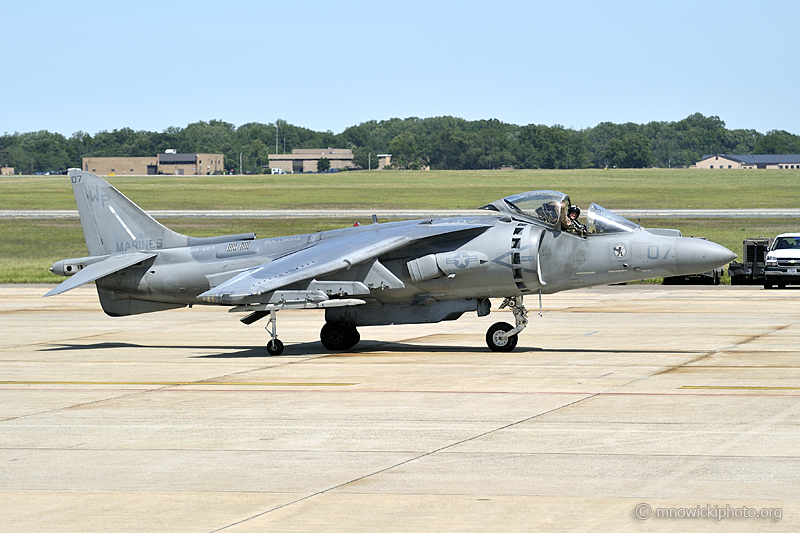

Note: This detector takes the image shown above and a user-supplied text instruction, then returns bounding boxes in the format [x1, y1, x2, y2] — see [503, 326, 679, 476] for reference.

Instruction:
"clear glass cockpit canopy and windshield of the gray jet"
[481, 191, 639, 235]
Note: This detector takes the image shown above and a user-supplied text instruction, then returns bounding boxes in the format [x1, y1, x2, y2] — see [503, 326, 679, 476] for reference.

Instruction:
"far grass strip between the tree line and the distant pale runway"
[0, 169, 800, 210]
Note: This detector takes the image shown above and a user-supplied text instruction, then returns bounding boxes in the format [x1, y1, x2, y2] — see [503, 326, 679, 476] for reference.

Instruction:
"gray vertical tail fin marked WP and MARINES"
[69, 168, 190, 255]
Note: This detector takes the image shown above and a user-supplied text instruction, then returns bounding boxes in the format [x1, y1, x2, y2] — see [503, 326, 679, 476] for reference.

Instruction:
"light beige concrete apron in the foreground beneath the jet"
[0, 285, 800, 532]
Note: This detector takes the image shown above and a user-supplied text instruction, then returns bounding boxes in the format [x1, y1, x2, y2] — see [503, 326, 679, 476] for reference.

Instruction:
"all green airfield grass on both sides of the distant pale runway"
[0, 170, 800, 283]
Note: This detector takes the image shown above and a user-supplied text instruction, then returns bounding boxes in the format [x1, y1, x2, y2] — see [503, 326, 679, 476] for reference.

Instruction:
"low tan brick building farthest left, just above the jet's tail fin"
[83, 150, 225, 176]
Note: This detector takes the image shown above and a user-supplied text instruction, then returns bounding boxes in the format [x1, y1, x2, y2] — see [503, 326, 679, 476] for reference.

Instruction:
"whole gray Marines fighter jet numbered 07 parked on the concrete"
[45, 169, 736, 355]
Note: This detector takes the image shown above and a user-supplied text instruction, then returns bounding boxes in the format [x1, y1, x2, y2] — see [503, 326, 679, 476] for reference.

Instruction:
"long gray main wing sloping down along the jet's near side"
[198, 222, 491, 304]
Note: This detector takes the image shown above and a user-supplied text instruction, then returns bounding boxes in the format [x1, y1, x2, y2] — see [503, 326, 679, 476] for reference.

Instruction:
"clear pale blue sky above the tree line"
[0, 0, 800, 136]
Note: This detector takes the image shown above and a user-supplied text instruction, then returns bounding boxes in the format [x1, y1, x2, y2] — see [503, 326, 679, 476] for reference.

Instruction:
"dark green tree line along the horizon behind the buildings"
[0, 113, 800, 174]
